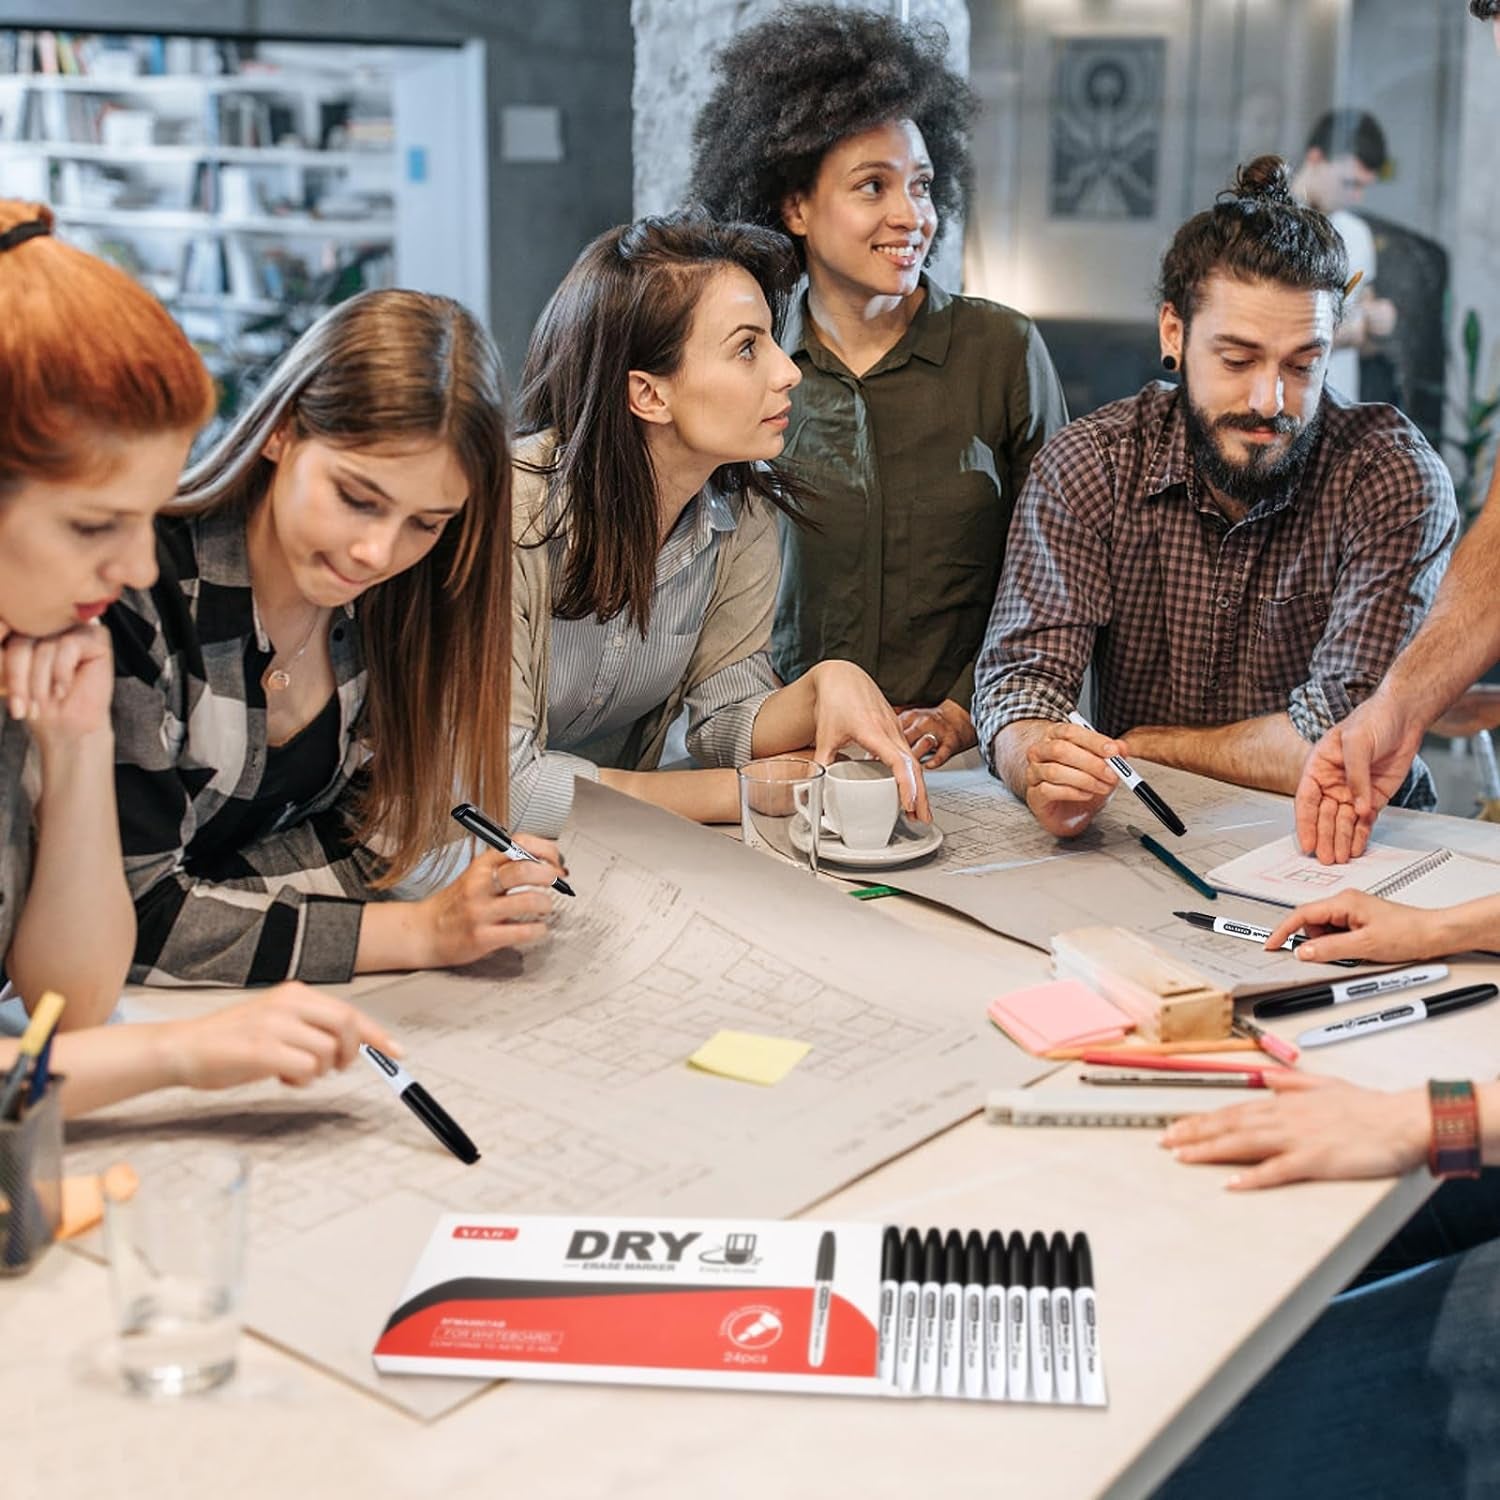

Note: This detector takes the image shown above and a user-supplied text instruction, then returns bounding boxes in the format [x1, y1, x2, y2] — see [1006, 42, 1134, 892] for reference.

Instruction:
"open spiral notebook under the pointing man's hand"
[1208, 837, 1500, 911]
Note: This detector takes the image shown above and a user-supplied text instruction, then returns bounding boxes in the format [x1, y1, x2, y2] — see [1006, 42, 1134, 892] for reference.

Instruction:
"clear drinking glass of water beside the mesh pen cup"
[105, 1146, 249, 1397]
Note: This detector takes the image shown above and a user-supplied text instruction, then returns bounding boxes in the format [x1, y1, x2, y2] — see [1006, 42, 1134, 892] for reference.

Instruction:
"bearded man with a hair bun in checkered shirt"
[975, 156, 1458, 837]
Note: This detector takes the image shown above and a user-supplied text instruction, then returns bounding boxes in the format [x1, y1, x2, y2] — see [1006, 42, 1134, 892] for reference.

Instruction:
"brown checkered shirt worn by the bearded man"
[974, 383, 1458, 807]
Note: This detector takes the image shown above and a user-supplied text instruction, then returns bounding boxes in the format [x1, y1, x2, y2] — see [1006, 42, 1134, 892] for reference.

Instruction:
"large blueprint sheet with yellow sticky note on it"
[69, 782, 1049, 1418]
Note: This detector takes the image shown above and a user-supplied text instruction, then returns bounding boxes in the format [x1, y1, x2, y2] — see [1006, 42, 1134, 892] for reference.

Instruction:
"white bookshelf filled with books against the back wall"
[0, 29, 489, 423]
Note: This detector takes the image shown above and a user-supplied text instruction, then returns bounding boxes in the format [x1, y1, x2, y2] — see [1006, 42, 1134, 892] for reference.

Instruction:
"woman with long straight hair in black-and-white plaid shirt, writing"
[107, 291, 558, 984]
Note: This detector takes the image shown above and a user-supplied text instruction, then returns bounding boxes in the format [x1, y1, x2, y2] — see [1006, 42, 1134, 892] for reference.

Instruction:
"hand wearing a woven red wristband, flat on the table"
[1161, 1070, 1433, 1191]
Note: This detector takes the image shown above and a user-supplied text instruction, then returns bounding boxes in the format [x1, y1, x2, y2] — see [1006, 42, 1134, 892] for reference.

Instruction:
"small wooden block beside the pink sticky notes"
[1052, 927, 1235, 1041]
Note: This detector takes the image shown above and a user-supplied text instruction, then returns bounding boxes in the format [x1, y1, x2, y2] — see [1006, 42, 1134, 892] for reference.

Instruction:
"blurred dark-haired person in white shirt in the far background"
[1292, 110, 1397, 401]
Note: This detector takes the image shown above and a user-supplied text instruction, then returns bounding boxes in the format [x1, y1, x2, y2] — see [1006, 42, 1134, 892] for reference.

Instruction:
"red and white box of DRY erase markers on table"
[375, 1214, 1106, 1406]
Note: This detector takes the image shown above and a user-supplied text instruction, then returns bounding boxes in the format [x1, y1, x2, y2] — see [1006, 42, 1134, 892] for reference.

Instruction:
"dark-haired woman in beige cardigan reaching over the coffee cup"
[510, 215, 927, 833]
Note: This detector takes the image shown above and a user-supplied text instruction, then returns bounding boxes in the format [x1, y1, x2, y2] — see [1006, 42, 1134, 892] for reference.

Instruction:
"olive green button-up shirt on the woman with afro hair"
[773, 276, 1068, 708]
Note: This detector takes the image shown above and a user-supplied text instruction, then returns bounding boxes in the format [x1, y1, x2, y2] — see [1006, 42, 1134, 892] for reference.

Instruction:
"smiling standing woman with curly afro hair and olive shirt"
[690, 6, 1067, 768]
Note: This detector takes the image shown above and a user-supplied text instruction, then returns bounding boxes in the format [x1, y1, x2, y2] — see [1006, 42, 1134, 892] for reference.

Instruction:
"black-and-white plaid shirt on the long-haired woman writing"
[105, 509, 380, 986]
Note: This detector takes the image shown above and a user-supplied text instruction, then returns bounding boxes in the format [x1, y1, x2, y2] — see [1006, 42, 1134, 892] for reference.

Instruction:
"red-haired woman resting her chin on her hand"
[0, 201, 393, 1115]
